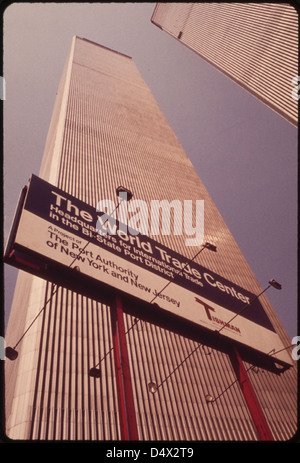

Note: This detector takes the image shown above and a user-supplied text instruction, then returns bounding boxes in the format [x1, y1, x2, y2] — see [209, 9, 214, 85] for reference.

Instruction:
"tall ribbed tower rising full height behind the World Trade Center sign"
[5, 37, 297, 441]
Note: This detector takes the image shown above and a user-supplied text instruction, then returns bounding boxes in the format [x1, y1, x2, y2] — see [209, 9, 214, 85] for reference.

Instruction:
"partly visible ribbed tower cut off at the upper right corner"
[152, 2, 298, 126]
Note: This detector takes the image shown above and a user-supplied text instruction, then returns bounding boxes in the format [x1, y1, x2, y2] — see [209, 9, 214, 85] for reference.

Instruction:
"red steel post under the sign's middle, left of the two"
[111, 296, 138, 440]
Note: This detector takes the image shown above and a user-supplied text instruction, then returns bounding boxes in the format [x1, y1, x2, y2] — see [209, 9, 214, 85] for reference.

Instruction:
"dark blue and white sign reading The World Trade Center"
[6, 175, 291, 364]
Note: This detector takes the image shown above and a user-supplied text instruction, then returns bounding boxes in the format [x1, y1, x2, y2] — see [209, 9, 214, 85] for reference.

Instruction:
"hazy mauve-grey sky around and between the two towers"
[3, 2, 298, 339]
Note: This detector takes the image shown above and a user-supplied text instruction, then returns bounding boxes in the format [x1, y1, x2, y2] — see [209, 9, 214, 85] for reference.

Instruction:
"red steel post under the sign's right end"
[229, 347, 274, 441]
